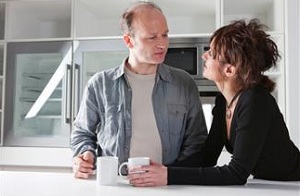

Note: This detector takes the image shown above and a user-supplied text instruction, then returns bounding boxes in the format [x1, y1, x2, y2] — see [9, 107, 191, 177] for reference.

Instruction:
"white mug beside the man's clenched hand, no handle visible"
[97, 156, 118, 185]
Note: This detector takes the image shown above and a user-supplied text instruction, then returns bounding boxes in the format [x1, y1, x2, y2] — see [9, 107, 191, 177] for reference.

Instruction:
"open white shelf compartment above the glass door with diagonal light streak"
[6, 0, 72, 40]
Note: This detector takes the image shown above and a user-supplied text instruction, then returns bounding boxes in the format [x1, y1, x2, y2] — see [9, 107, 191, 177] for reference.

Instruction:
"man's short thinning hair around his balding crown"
[120, 1, 162, 34]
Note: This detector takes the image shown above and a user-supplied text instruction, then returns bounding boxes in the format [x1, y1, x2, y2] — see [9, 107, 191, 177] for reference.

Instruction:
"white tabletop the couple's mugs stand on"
[0, 171, 300, 196]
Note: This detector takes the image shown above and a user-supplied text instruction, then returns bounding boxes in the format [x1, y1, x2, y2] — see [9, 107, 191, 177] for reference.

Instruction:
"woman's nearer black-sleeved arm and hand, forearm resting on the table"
[129, 89, 271, 186]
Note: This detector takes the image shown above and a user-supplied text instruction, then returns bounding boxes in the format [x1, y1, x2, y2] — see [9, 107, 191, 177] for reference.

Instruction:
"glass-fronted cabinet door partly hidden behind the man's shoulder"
[73, 39, 128, 116]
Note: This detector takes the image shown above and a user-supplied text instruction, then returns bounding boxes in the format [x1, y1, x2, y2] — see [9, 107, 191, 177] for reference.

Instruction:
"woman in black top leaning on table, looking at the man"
[128, 19, 300, 186]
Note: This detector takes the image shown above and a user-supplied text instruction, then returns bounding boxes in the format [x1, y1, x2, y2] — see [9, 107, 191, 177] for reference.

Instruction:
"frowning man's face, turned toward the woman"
[129, 9, 169, 64]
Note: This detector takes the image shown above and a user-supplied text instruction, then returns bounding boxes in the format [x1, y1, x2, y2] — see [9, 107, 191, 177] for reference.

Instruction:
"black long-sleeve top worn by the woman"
[168, 86, 300, 185]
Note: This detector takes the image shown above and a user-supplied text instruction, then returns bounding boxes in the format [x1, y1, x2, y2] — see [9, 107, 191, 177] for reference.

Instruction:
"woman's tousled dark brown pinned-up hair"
[210, 19, 280, 92]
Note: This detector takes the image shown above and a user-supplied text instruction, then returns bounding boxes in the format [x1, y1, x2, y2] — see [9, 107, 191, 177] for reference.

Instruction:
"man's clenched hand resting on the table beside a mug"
[73, 151, 95, 179]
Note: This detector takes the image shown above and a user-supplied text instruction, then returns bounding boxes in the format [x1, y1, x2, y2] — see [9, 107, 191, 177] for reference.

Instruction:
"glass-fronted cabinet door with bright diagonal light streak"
[4, 41, 72, 147]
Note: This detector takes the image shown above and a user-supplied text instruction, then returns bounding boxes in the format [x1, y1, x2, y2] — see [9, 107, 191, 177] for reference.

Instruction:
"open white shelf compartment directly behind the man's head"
[75, 0, 220, 37]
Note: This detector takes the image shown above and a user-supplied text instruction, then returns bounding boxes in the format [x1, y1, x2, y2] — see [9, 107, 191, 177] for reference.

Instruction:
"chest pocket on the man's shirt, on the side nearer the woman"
[167, 104, 187, 135]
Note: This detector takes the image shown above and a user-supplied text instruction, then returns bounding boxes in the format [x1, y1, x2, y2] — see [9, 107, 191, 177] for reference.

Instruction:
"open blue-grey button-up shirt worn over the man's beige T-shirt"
[71, 61, 207, 164]
